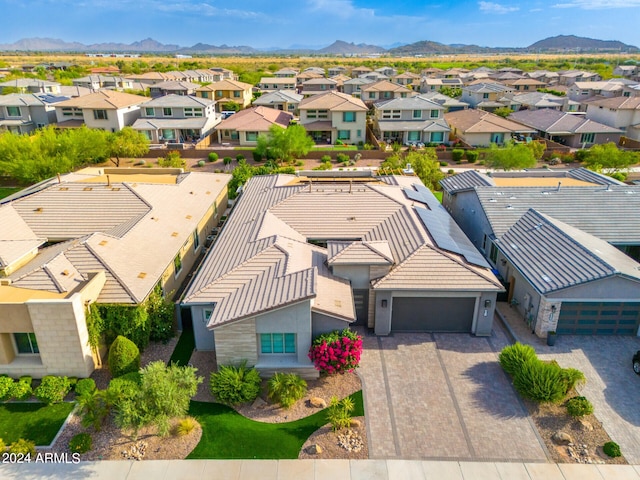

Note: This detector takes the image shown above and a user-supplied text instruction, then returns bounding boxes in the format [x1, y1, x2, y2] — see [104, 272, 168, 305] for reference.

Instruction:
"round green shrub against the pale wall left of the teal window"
[209, 361, 261, 405]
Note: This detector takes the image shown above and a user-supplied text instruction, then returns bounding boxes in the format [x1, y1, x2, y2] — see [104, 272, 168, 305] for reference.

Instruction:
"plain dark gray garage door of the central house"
[391, 297, 476, 333]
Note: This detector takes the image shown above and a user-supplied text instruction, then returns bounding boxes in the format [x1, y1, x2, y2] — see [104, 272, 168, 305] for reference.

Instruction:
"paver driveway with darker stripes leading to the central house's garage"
[358, 327, 548, 462]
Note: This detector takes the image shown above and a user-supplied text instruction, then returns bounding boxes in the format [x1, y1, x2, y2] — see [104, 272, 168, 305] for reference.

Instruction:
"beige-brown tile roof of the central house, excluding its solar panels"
[184, 175, 501, 328]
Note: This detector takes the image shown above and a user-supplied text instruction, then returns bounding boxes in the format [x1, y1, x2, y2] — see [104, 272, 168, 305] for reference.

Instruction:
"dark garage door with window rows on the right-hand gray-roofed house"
[556, 302, 640, 335]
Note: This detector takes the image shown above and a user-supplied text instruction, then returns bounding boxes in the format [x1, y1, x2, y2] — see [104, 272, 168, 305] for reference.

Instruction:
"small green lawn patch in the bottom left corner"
[0, 402, 74, 445]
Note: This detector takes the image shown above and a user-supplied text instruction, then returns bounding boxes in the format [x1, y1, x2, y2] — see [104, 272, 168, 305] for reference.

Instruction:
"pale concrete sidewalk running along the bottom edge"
[0, 460, 640, 480]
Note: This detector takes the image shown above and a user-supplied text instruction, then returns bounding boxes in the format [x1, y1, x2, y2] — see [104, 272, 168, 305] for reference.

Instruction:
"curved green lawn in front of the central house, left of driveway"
[187, 391, 364, 459]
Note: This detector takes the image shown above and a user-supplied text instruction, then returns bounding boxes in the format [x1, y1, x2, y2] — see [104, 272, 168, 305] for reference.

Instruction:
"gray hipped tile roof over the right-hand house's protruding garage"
[497, 209, 640, 294]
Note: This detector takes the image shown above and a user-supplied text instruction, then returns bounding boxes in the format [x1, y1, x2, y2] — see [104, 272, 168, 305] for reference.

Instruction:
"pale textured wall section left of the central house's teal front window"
[214, 318, 258, 366]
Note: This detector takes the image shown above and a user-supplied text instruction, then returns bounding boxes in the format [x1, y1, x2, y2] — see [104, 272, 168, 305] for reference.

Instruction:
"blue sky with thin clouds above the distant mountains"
[0, 0, 640, 48]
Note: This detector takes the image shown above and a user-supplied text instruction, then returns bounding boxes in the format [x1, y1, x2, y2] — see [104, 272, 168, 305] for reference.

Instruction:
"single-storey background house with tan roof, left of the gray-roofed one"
[444, 109, 535, 147]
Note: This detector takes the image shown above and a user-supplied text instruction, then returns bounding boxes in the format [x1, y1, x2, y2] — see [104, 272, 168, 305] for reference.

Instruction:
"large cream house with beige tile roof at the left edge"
[0, 168, 230, 378]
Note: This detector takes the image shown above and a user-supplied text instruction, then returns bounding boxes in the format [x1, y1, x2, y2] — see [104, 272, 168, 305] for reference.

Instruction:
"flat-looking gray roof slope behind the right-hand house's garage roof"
[476, 185, 640, 245]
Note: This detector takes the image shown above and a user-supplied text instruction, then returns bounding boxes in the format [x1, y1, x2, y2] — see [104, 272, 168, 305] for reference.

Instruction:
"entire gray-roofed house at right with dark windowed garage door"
[441, 168, 640, 336]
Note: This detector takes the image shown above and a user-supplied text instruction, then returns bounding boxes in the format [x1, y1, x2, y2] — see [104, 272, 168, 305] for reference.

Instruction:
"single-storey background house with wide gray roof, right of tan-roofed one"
[508, 108, 622, 148]
